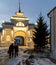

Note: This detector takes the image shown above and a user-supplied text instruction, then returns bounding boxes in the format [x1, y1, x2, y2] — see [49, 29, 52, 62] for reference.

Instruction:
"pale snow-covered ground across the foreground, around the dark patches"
[0, 49, 56, 65]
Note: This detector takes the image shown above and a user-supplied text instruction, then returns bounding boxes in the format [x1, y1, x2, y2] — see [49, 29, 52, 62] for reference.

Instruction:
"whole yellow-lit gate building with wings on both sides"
[0, 5, 34, 48]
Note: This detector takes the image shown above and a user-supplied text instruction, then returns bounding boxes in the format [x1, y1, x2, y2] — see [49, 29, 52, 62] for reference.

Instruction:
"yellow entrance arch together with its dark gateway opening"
[14, 30, 27, 45]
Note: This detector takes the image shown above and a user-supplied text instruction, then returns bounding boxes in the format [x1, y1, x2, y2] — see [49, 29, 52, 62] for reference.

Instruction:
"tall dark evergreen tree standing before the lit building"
[33, 15, 48, 51]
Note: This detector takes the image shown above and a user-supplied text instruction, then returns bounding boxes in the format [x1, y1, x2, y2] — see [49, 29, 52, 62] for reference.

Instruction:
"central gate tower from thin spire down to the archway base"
[10, 2, 29, 48]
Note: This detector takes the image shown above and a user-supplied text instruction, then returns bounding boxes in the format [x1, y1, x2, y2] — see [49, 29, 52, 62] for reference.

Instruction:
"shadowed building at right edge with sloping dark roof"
[48, 7, 56, 58]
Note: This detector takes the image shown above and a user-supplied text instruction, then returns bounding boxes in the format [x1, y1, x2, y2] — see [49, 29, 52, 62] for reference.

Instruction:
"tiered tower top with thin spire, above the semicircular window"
[11, 0, 29, 26]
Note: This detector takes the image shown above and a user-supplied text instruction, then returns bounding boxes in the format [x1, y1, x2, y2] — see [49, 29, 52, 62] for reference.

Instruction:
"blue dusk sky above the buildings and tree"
[0, 0, 56, 26]
